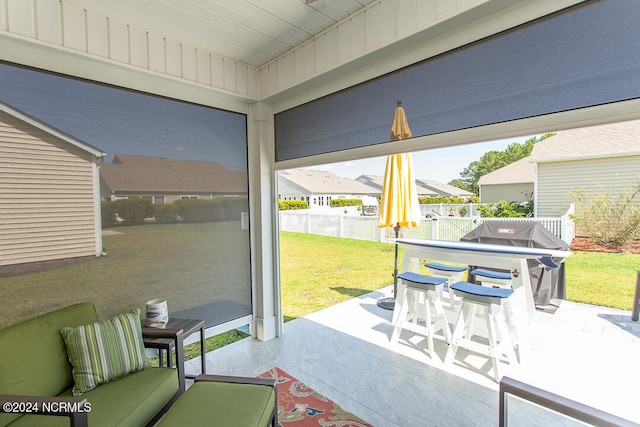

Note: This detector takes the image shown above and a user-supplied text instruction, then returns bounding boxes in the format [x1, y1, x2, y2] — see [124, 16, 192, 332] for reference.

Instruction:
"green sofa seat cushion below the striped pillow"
[11, 368, 180, 427]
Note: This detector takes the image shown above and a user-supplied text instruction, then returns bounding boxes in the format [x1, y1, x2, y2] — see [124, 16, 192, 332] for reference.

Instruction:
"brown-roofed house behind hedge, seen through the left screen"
[100, 154, 248, 204]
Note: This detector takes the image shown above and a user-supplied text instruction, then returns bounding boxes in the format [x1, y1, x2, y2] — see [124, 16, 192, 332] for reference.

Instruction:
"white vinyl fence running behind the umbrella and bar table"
[279, 209, 575, 243]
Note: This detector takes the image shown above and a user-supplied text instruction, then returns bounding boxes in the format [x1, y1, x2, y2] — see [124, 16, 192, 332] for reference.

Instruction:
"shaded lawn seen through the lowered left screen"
[0, 222, 251, 327]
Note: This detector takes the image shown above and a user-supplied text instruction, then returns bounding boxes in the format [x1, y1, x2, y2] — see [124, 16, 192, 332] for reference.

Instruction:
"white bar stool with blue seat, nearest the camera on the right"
[445, 282, 517, 382]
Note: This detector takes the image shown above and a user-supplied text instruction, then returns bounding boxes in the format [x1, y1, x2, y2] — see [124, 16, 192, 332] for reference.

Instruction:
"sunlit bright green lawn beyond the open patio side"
[280, 232, 640, 319]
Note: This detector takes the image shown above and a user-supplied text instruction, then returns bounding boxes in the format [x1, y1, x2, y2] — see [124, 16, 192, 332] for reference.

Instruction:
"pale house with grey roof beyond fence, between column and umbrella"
[278, 169, 380, 209]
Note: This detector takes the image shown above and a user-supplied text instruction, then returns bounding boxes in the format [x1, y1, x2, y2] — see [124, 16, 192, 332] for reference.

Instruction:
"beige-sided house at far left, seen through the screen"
[0, 102, 104, 266]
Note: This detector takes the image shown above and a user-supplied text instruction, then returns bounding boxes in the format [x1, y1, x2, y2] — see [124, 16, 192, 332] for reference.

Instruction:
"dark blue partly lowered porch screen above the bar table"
[275, 0, 640, 161]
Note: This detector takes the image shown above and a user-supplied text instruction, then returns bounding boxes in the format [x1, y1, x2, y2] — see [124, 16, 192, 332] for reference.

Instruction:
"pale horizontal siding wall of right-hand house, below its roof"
[536, 155, 640, 235]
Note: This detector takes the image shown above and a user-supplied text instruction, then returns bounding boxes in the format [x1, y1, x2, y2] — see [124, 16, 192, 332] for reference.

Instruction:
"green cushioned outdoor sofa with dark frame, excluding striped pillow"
[0, 303, 185, 427]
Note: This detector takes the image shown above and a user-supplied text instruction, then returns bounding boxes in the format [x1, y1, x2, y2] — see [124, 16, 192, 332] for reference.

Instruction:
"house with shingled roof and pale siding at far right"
[531, 120, 640, 221]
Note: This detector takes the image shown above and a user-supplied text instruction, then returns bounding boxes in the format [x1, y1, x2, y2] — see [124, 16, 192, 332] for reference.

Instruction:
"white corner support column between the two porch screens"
[247, 102, 282, 341]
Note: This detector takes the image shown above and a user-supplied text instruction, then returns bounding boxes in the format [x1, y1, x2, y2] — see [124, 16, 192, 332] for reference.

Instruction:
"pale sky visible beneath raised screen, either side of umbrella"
[306, 135, 535, 183]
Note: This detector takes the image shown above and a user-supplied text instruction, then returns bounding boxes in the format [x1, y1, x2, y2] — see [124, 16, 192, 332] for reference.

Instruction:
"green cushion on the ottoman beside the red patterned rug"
[156, 381, 276, 427]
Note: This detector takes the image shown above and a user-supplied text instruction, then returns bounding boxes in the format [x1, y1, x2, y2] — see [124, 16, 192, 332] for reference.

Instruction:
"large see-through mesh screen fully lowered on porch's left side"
[0, 63, 252, 327]
